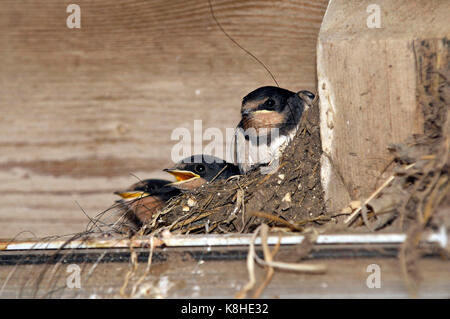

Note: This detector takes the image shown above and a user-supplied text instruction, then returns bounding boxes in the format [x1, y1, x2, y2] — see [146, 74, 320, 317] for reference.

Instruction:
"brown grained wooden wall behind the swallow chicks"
[0, 0, 327, 237]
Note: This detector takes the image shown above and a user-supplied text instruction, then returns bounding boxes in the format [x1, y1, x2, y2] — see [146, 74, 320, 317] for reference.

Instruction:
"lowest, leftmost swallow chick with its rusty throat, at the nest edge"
[114, 179, 180, 227]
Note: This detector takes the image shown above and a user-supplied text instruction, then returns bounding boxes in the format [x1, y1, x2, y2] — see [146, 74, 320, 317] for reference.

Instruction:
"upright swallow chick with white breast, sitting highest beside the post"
[234, 86, 314, 174]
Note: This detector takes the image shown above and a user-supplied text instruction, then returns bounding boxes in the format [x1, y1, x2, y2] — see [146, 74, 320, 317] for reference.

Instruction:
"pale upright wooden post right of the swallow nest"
[317, 0, 450, 211]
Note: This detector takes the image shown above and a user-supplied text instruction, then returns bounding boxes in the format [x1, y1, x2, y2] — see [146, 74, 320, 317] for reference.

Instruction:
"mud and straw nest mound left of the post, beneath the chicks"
[134, 103, 329, 234]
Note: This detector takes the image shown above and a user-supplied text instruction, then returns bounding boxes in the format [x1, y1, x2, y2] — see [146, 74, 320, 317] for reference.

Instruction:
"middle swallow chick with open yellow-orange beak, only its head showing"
[164, 155, 239, 190]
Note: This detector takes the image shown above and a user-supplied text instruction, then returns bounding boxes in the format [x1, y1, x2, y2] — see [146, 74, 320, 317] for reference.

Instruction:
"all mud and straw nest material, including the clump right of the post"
[96, 67, 450, 238]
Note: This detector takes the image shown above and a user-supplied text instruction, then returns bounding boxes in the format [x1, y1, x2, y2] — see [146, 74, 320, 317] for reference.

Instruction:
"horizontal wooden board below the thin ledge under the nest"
[0, 248, 450, 298]
